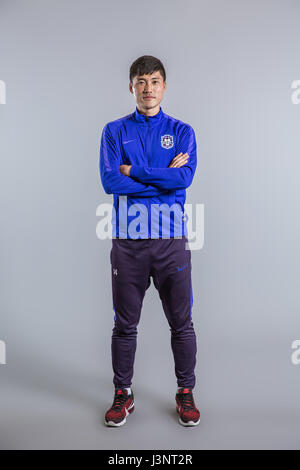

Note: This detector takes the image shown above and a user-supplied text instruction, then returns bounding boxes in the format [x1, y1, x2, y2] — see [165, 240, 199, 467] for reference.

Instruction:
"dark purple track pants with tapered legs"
[110, 236, 197, 388]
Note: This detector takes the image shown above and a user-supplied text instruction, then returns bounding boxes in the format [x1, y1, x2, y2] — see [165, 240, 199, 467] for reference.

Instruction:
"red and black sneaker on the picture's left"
[105, 388, 134, 426]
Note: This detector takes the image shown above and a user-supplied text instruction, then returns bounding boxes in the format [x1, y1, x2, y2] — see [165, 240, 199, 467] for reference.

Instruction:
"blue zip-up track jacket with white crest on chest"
[99, 107, 197, 238]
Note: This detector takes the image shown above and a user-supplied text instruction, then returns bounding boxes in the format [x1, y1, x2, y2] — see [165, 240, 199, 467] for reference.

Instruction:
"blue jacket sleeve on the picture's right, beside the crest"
[130, 125, 197, 190]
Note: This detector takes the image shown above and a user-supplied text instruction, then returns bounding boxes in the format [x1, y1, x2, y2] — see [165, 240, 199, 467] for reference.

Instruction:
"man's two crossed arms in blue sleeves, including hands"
[100, 125, 197, 197]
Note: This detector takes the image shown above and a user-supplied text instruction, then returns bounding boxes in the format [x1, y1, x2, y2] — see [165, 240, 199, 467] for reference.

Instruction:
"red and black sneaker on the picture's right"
[176, 388, 200, 426]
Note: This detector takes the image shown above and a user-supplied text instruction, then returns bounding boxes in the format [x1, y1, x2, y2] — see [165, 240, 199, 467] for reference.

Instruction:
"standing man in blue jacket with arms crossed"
[100, 56, 200, 426]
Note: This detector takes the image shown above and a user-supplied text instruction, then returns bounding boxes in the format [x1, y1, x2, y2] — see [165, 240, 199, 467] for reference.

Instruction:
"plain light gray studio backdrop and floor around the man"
[0, 0, 300, 449]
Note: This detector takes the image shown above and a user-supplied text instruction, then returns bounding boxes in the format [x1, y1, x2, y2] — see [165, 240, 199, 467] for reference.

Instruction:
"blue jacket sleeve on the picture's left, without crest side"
[99, 124, 168, 197]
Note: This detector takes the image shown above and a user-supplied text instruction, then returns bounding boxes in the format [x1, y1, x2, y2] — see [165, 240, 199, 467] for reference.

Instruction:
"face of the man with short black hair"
[129, 71, 167, 115]
